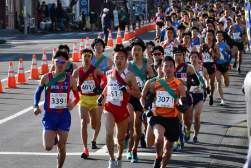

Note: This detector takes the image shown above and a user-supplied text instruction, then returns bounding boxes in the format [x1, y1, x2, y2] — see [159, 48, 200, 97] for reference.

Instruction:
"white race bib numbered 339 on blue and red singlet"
[50, 93, 67, 109]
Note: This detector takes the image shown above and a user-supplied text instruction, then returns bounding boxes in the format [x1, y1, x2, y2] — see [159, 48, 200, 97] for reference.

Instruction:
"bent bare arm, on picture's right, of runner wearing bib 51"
[126, 72, 141, 98]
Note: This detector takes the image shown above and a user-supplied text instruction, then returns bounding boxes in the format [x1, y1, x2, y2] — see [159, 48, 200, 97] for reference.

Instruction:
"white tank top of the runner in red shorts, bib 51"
[107, 69, 129, 106]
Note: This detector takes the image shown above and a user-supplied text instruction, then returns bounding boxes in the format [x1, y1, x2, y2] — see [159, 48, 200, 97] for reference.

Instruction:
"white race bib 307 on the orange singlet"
[156, 91, 174, 108]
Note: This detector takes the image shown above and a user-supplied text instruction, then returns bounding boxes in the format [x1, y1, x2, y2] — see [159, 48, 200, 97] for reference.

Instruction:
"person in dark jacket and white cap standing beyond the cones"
[102, 8, 111, 45]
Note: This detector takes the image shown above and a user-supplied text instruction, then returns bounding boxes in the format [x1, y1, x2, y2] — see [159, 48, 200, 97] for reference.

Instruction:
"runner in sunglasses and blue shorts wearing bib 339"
[33, 51, 79, 168]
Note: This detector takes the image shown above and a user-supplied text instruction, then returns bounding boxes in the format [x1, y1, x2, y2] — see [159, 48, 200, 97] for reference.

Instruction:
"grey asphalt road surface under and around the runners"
[0, 32, 251, 168]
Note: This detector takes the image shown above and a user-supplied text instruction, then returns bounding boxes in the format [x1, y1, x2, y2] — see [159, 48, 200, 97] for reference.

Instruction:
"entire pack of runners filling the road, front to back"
[34, 0, 249, 168]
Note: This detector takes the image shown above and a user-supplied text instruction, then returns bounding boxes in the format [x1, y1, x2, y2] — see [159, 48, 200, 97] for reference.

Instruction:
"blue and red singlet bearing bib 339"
[44, 73, 71, 113]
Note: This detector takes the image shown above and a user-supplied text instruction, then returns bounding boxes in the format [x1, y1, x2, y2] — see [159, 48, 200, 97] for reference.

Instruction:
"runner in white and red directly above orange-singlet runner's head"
[162, 27, 179, 57]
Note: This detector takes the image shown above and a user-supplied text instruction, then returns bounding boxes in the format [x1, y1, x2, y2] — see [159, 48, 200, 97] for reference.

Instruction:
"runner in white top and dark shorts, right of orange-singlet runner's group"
[189, 51, 209, 143]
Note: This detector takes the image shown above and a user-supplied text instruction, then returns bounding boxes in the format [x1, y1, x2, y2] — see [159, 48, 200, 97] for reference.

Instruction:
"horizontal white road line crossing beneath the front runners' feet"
[0, 152, 211, 158]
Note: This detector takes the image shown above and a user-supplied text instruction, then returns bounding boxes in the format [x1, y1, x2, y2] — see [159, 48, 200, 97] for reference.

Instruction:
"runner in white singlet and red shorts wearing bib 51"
[97, 44, 141, 168]
